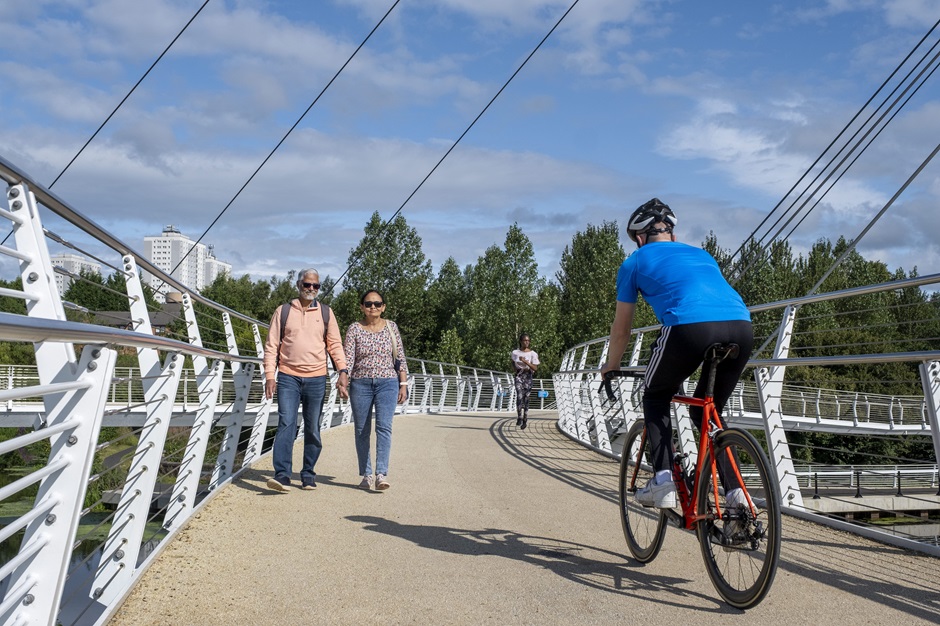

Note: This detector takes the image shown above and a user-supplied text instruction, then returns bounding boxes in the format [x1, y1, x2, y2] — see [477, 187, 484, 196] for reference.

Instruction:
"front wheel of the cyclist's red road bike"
[620, 420, 666, 563]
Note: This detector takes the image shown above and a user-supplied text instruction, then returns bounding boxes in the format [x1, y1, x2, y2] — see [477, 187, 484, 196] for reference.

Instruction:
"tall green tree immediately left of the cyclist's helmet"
[555, 222, 625, 350]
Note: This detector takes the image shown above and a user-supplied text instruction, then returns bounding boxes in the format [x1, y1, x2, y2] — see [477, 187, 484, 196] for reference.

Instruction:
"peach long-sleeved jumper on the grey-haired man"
[264, 299, 346, 380]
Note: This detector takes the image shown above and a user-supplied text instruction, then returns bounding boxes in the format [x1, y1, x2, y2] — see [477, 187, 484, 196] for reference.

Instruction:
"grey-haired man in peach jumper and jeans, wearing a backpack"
[264, 269, 349, 492]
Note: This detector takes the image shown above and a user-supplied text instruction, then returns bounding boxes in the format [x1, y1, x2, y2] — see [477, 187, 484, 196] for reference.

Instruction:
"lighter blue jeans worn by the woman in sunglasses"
[349, 378, 398, 476]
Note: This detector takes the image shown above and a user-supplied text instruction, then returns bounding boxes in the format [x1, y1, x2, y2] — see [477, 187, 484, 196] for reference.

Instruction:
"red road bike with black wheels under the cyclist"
[601, 344, 781, 609]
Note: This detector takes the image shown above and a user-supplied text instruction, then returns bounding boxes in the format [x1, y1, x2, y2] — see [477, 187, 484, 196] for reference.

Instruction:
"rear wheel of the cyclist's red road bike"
[696, 428, 780, 609]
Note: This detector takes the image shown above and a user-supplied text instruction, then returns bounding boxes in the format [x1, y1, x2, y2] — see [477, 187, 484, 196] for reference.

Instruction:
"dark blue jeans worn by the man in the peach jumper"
[272, 372, 326, 480]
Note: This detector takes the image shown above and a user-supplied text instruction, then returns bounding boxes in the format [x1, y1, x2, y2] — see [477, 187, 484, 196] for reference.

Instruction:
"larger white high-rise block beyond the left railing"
[144, 224, 232, 301]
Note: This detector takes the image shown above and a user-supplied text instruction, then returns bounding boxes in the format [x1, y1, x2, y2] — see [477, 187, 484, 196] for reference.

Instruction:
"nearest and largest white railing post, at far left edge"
[0, 183, 117, 624]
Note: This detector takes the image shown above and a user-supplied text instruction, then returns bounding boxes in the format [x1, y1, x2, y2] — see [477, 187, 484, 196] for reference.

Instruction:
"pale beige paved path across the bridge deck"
[110, 412, 940, 626]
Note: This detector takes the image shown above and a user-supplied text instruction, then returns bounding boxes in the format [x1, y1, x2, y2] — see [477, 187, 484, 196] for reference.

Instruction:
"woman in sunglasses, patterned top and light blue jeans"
[344, 289, 408, 491]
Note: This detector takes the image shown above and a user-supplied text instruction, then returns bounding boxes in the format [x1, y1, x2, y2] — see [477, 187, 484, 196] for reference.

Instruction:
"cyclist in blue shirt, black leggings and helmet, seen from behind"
[601, 198, 754, 508]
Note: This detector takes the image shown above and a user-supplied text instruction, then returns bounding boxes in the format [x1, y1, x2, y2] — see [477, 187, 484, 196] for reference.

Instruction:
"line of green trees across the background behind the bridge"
[0, 212, 940, 386]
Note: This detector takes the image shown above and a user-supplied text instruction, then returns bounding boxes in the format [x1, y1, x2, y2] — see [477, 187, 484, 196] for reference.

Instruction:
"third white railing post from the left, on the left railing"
[163, 294, 224, 530]
